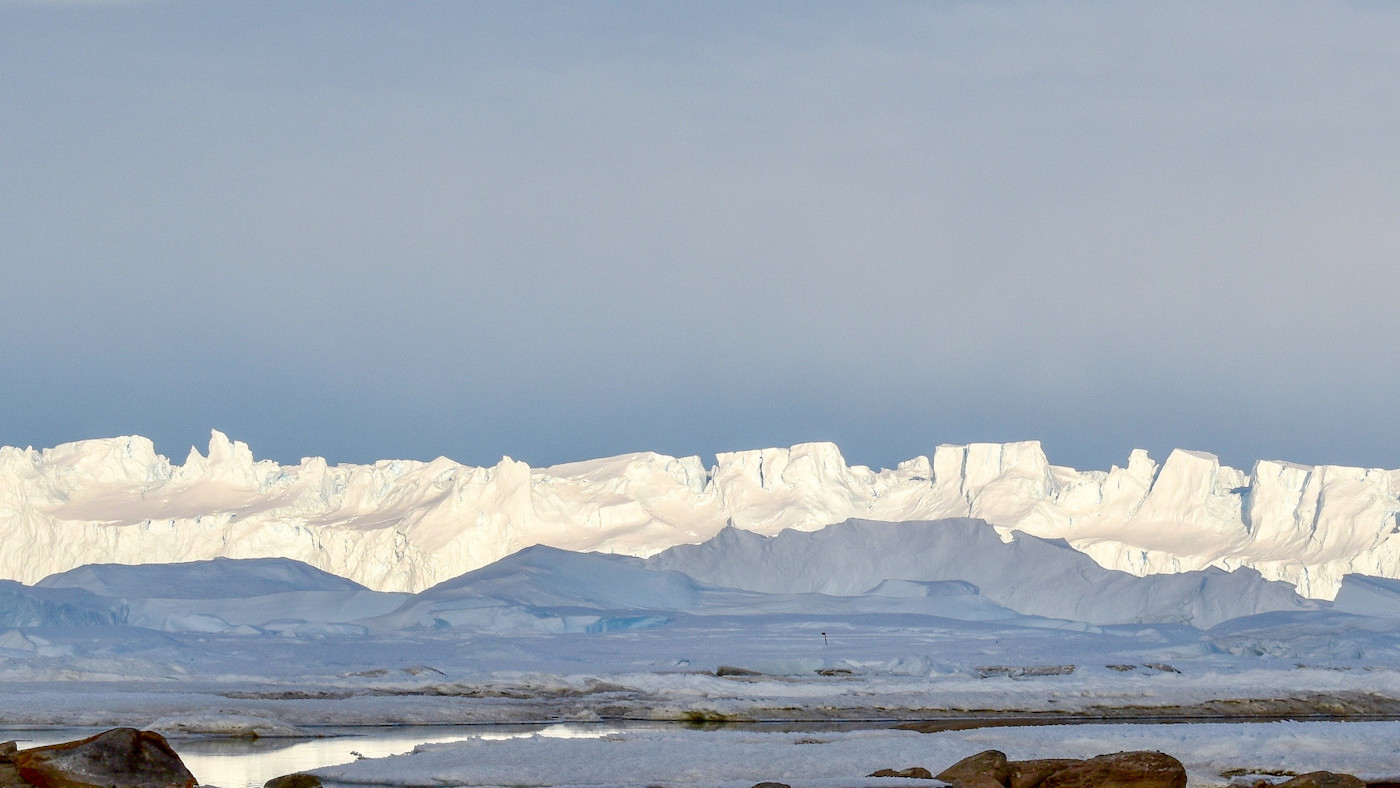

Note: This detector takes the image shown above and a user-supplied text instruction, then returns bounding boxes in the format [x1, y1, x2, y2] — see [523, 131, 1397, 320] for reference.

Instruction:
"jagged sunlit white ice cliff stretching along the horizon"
[0, 431, 1400, 598]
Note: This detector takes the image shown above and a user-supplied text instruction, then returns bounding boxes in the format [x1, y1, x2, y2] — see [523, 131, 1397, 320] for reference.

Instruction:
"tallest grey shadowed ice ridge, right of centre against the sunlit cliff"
[647, 519, 1317, 628]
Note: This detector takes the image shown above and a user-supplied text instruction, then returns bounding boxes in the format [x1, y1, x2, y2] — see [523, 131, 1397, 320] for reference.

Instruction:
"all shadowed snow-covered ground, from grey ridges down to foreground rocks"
[0, 519, 1400, 788]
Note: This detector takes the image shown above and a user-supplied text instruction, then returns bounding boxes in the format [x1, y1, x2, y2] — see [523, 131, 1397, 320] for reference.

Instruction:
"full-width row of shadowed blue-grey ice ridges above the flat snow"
[0, 534, 1400, 651]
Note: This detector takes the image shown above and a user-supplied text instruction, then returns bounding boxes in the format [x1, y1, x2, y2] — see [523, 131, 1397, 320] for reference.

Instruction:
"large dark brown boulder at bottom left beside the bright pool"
[14, 728, 195, 788]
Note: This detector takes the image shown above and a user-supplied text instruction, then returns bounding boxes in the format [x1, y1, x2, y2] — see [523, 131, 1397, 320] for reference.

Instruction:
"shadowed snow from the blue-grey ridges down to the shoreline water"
[8, 543, 1400, 732]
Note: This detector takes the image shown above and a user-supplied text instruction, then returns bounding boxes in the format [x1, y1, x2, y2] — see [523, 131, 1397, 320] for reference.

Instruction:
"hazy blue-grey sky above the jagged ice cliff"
[0, 0, 1400, 469]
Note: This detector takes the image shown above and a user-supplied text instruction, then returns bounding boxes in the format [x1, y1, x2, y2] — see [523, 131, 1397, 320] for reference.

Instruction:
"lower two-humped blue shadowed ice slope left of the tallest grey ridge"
[13, 546, 1035, 637]
